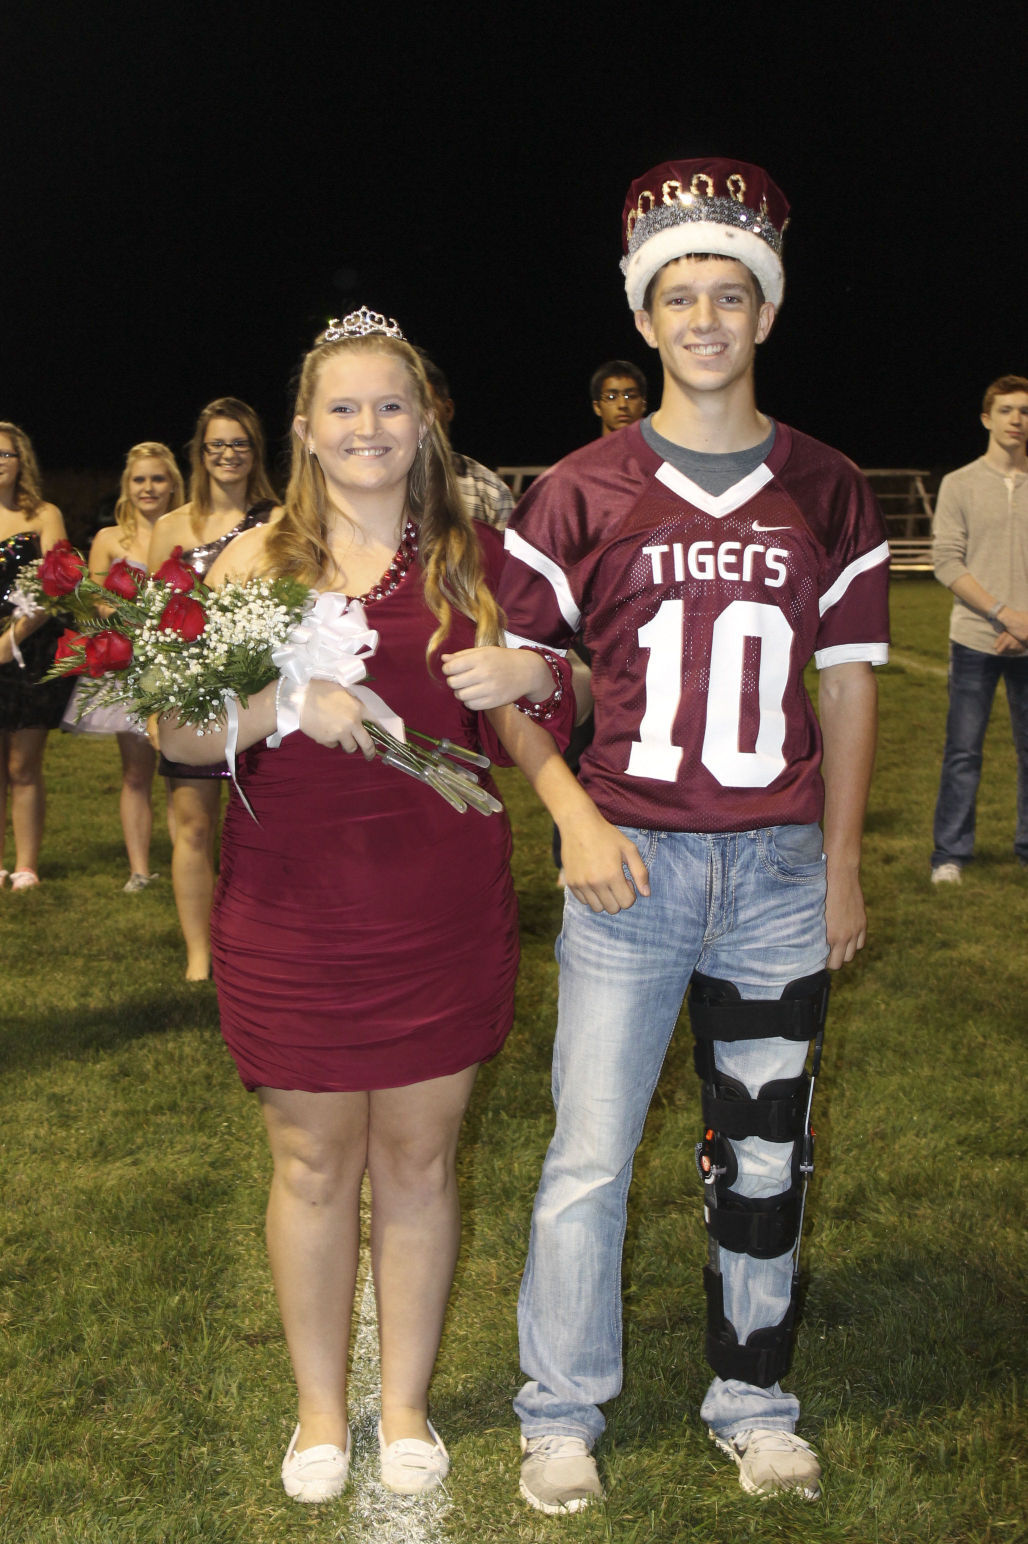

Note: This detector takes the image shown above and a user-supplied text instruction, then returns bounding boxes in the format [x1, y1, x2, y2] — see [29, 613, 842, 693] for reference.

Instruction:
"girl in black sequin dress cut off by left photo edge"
[0, 423, 73, 891]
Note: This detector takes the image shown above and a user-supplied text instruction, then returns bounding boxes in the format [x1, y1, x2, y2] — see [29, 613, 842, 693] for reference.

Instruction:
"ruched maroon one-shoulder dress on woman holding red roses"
[211, 533, 519, 1092]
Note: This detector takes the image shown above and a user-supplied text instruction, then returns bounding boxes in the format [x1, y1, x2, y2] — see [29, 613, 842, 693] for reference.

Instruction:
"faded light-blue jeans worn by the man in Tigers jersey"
[514, 826, 827, 1447]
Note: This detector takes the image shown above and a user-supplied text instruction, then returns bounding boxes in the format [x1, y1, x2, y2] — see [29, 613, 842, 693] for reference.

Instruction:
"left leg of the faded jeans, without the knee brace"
[514, 831, 707, 1447]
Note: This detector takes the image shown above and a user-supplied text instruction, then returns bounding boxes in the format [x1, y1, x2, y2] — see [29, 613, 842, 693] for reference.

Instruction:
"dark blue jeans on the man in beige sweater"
[932, 644, 1028, 868]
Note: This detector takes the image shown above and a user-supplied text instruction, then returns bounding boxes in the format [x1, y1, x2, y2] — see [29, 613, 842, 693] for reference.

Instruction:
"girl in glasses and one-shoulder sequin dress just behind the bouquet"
[148, 397, 275, 980]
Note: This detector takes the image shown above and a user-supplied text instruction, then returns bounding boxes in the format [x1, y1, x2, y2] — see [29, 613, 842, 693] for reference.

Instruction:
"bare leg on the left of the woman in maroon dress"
[258, 1089, 369, 1451]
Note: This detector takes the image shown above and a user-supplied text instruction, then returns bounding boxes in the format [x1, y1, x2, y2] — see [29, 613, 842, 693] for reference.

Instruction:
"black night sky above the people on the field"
[0, 0, 1028, 487]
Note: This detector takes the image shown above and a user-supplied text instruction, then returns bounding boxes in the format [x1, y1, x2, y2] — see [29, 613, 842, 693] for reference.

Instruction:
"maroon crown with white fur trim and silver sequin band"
[621, 157, 789, 310]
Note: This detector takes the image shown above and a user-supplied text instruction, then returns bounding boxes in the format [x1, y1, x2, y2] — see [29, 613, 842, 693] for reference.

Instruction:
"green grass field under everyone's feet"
[0, 579, 1028, 1544]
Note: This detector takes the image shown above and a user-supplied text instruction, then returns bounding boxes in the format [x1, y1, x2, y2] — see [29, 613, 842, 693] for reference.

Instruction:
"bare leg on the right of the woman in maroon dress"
[367, 1067, 477, 1444]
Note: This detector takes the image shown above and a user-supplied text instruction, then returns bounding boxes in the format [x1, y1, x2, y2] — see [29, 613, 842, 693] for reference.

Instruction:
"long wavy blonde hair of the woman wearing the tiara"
[265, 334, 503, 661]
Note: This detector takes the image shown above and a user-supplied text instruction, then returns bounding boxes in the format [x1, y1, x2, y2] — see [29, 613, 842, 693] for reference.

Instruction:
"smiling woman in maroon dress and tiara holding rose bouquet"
[161, 312, 570, 1501]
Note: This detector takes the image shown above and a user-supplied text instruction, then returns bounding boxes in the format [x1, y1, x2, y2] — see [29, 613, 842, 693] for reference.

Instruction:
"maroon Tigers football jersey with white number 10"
[499, 423, 889, 832]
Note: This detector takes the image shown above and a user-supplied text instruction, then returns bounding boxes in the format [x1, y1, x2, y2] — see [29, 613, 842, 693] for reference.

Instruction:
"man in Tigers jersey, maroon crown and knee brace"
[451, 161, 889, 1513]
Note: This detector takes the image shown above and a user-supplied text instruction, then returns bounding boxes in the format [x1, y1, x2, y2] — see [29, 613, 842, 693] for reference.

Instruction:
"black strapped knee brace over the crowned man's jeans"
[688, 971, 829, 1388]
